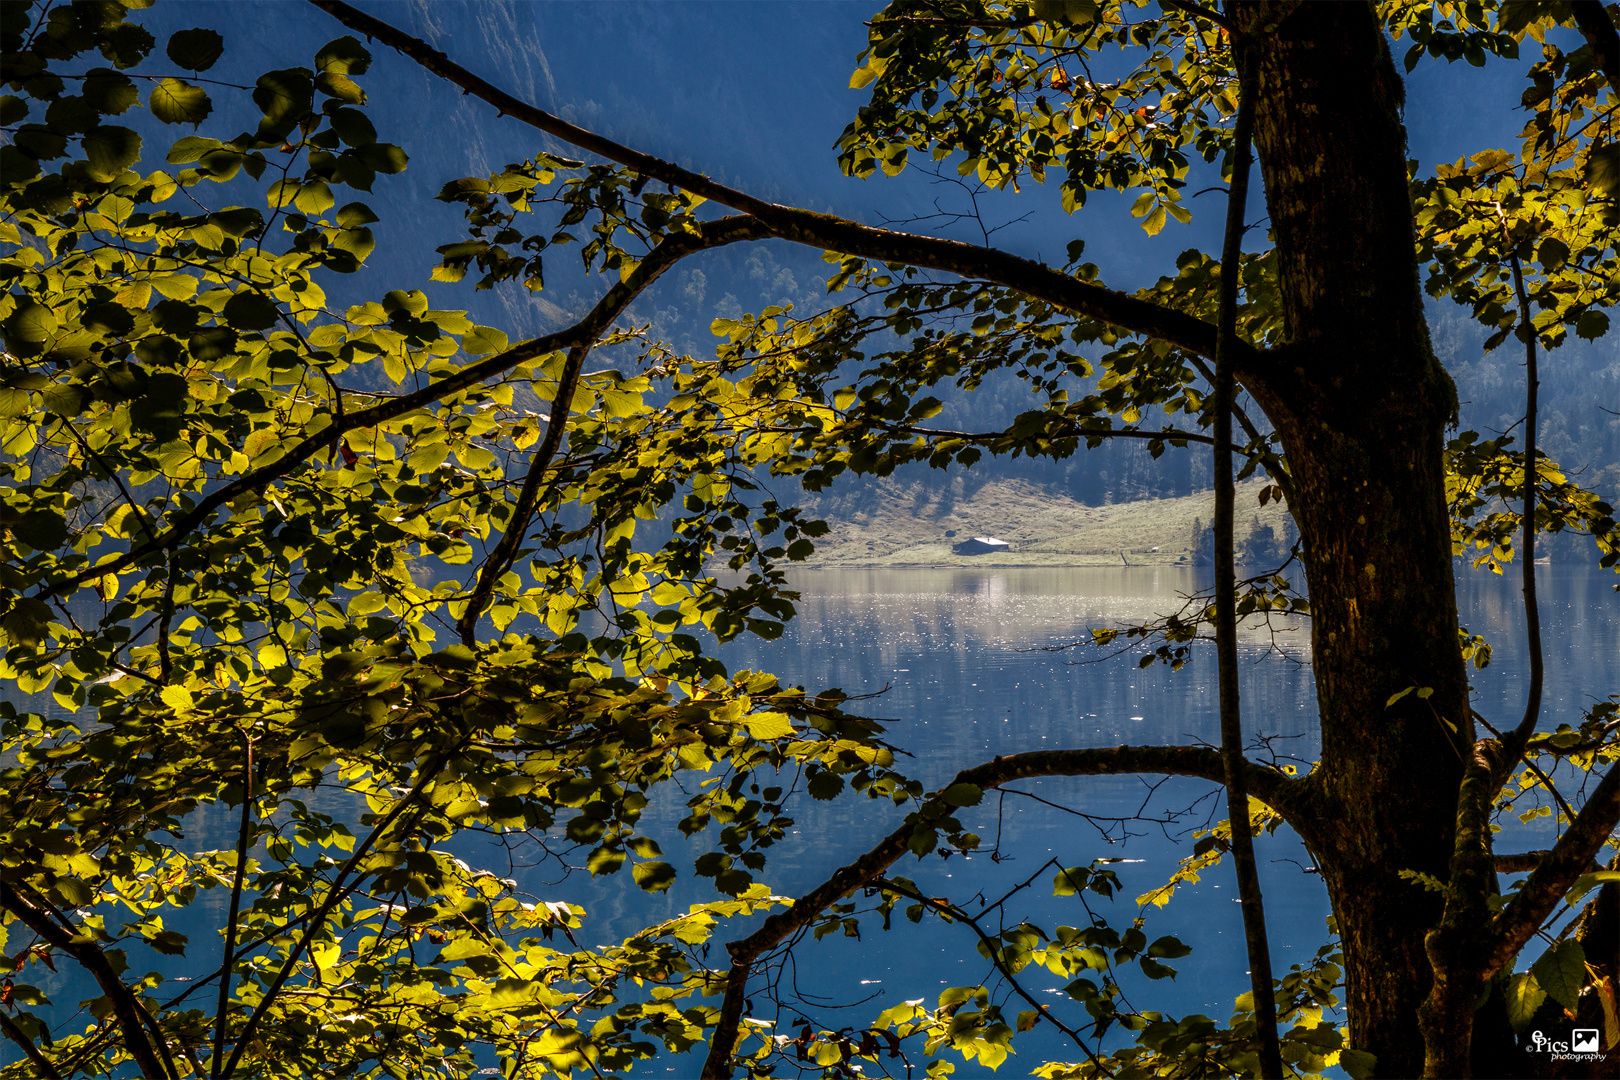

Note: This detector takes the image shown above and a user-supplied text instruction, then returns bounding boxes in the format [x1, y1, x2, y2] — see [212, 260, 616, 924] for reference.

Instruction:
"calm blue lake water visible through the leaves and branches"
[9, 567, 1620, 1075]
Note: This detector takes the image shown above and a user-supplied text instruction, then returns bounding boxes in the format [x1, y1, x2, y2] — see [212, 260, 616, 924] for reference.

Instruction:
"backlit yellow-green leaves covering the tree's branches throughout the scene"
[0, 0, 1620, 1080]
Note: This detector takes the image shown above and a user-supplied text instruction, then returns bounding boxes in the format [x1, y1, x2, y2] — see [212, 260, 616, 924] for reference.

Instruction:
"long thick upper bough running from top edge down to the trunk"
[309, 0, 1264, 372]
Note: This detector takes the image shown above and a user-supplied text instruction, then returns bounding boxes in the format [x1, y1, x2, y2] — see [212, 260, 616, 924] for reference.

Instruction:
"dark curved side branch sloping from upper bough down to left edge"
[39, 217, 768, 599]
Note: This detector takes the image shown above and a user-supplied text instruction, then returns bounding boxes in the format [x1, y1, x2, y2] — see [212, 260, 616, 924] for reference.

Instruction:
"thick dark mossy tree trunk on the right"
[1231, 3, 1496, 1077]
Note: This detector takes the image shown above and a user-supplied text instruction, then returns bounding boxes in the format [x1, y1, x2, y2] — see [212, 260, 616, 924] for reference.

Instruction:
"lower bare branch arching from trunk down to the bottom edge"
[703, 746, 1309, 1080]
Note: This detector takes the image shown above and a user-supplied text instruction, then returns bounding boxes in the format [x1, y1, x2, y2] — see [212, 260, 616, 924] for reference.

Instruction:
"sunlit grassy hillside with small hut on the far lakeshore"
[790, 478, 1288, 567]
